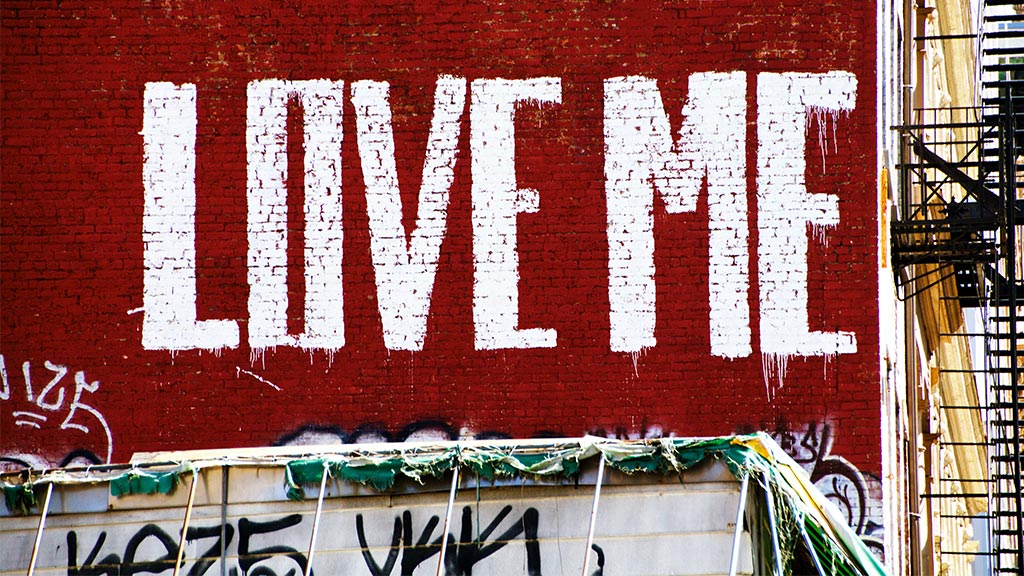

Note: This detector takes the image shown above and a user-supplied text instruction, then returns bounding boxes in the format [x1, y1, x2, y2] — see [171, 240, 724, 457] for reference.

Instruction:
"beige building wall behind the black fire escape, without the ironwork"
[882, 0, 988, 575]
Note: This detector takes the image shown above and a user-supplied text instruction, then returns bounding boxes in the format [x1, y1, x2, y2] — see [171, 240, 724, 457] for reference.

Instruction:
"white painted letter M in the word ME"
[604, 72, 751, 358]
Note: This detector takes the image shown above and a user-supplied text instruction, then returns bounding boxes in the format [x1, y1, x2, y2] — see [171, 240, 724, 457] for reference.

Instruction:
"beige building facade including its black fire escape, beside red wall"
[880, 1, 1024, 574]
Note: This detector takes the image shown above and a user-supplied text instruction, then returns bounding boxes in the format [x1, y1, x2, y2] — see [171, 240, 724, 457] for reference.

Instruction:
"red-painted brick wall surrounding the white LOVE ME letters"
[0, 0, 880, 479]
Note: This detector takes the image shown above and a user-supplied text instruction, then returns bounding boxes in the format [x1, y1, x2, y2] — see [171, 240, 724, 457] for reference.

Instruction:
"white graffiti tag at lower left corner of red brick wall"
[0, 355, 114, 469]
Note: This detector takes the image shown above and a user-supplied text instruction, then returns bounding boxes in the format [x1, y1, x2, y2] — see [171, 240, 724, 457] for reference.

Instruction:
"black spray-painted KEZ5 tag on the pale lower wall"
[68, 515, 312, 576]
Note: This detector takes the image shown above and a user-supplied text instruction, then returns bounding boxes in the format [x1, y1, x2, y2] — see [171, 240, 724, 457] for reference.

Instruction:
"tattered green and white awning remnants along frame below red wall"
[2, 434, 885, 576]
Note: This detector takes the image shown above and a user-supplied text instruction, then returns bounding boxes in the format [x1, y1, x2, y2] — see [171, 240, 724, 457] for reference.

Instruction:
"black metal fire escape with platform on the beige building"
[891, 0, 1024, 574]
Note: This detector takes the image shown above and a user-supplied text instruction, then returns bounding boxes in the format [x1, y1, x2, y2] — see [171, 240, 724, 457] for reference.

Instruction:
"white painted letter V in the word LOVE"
[352, 76, 466, 351]
